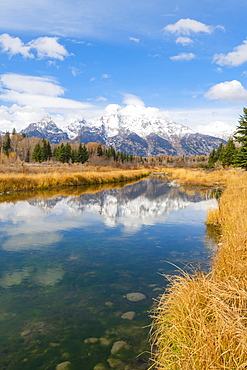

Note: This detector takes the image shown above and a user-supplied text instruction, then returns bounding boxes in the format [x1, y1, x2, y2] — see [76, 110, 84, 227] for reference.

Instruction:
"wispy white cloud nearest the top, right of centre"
[164, 18, 223, 36]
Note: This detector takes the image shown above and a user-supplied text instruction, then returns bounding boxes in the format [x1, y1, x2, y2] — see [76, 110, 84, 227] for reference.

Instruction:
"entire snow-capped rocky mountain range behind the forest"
[21, 104, 225, 157]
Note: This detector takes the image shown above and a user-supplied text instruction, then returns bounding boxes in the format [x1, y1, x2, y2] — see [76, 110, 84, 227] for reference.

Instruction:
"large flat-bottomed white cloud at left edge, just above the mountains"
[0, 73, 92, 109]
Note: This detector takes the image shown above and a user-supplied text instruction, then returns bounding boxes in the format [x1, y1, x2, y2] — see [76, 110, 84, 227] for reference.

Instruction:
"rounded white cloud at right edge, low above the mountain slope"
[204, 80, 247, 102]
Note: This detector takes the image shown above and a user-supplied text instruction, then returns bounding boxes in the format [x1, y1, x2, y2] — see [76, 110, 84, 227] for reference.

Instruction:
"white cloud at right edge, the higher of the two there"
[213, 40, 247, 67]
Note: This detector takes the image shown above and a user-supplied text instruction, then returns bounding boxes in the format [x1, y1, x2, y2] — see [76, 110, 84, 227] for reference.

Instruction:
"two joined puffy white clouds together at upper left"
[0, 33, 70, 60]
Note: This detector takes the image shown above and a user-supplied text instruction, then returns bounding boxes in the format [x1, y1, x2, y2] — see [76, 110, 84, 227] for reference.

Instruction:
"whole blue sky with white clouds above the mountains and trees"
[0, 0, 247, 134]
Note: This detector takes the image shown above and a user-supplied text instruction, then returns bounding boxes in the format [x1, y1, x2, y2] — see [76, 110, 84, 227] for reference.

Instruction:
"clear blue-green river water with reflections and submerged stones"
[0, 178, 216, 370]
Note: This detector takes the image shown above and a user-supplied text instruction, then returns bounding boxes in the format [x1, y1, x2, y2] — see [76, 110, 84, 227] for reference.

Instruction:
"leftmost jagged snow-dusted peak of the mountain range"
[21, 115, 69, 143]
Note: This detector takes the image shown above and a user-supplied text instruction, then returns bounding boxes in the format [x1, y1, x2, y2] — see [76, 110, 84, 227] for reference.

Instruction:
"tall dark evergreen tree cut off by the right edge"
[234, 108, 247, 170]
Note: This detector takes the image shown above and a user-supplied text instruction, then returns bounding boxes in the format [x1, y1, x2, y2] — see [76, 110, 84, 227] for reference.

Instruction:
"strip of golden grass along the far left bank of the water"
[0, 168, 151, 193]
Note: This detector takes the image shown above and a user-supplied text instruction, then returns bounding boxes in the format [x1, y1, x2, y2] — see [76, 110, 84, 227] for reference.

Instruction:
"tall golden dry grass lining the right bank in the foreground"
[152, 170, 247, 370]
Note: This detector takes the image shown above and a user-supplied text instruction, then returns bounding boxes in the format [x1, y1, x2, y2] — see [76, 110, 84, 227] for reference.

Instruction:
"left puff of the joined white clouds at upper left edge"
[0, 33, 34, 58]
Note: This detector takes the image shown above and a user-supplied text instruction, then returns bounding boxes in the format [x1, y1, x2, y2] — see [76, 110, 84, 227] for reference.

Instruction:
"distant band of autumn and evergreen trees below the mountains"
[0, 129, 208, 167]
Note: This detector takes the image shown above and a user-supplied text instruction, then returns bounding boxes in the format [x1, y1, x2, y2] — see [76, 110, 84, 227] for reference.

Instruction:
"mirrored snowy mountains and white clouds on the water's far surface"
[0, 179, 215, 251]
